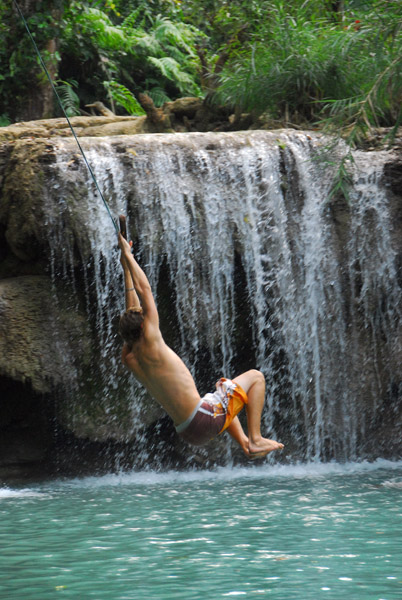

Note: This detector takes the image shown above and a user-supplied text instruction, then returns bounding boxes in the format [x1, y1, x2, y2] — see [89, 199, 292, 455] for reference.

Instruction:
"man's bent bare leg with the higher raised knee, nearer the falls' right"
[228, 369, 283, 456]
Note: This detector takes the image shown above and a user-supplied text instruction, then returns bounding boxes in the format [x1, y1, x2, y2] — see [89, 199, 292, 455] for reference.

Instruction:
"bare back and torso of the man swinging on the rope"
[123, 334, 200, 425]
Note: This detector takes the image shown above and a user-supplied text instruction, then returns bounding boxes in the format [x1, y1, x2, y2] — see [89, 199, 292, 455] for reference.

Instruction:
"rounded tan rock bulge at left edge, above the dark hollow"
[0, 276, 90, 394]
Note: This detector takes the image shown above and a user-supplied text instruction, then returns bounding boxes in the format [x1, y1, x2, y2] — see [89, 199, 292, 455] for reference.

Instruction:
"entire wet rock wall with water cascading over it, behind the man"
[0, 122, 402, 478]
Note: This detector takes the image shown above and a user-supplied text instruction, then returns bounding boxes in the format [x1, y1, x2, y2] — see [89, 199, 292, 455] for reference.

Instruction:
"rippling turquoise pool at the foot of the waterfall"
[0, 461, 402, 600]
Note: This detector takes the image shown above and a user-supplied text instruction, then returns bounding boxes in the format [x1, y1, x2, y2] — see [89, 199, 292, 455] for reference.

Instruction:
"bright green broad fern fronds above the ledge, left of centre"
[62, 2, 201, 114]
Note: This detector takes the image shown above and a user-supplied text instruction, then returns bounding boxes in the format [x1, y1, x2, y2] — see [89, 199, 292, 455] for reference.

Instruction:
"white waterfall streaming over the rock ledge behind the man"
[48, 131, 402, 460]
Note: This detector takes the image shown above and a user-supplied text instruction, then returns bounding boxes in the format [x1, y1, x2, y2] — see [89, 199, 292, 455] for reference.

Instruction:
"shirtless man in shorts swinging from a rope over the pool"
[119, 234, 283, 458]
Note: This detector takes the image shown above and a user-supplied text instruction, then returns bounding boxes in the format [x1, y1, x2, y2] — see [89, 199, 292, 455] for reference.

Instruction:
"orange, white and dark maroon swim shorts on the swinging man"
[176, 377, 248, 446]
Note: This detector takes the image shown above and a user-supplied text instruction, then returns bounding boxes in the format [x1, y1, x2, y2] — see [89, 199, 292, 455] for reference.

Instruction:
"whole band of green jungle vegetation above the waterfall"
[0, 0, 402, 143]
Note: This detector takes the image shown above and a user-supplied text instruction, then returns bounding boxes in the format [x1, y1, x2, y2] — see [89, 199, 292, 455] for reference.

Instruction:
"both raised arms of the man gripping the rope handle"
[119, 233, 159, 329]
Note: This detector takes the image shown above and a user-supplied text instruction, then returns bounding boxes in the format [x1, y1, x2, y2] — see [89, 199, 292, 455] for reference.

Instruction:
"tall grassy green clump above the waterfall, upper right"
[212, 0, 402, 138]
